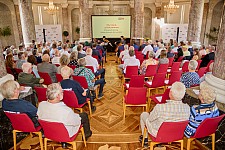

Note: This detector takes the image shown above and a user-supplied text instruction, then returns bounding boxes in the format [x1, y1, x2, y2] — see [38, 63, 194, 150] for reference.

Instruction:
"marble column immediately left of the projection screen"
[79, 0, 91, 42]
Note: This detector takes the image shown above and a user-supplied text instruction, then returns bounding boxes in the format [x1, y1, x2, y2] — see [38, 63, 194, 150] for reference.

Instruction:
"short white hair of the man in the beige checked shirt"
[170, 82, 186, 100]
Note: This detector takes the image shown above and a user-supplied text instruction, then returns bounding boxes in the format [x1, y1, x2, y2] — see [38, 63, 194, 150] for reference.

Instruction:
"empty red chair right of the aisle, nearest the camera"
[123, 87, 148, 119]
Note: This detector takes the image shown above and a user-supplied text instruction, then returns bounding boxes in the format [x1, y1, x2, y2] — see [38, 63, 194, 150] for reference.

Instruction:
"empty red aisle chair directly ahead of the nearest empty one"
[123, 75, 145, 93]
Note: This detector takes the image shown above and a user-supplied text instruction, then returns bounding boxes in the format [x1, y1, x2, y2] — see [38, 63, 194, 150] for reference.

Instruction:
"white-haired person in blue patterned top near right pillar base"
[180, 60, 200, 88]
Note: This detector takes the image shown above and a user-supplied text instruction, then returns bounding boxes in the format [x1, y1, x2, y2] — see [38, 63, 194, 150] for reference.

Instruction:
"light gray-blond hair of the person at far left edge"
[0, 80, 20, 99]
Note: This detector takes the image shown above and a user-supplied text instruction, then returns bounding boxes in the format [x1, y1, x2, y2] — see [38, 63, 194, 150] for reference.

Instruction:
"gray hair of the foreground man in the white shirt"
[46, 83, 61, 100]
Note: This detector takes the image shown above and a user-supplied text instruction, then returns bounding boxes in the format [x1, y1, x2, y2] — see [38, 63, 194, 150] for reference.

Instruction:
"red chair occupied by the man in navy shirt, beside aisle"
[63, 90, 92, 116]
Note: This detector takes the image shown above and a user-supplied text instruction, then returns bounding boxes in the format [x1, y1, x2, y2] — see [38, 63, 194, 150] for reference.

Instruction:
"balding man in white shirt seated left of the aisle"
[84, 48, 105, 78]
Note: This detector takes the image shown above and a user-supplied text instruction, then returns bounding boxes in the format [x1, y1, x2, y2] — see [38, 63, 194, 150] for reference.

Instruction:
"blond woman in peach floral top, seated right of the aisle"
[140, 51, 158, 74]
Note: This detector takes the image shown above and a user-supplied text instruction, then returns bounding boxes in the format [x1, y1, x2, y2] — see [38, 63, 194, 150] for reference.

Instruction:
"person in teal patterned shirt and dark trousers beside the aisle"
[74, 58, 105, 99]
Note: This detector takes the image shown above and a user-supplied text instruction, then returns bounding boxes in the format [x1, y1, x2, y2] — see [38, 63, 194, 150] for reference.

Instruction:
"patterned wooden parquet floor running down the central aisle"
[11, 54, 207, 150]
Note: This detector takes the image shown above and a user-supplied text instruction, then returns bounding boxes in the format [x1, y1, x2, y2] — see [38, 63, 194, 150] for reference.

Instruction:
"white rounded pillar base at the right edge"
[205, 74, 225, 112]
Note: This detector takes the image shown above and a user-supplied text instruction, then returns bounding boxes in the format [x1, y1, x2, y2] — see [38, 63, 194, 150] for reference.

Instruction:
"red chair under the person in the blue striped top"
[187, 114, 225, 150]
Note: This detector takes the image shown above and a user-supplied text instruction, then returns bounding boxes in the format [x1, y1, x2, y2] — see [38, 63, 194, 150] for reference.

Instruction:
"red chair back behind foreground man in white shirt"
[38, 119, 79, 142]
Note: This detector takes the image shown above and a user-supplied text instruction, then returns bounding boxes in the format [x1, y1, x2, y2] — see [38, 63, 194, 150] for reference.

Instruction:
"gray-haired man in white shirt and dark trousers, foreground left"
[37, 83, 92, 138]
